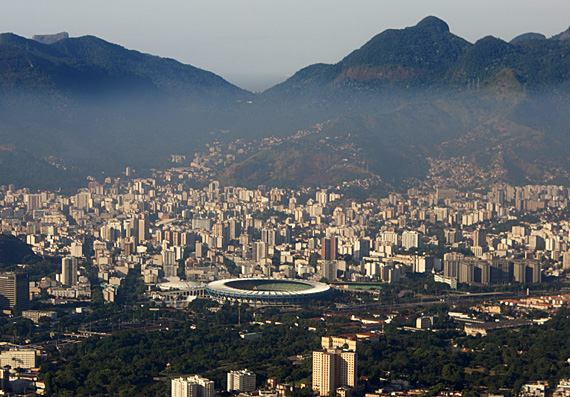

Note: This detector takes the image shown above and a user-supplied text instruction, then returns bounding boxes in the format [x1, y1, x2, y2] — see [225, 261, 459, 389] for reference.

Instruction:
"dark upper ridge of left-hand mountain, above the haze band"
[0, 34, 248, 101]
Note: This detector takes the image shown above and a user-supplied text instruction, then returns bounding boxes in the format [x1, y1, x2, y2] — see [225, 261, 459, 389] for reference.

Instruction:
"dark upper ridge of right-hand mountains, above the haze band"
[265, 17, 570, 97]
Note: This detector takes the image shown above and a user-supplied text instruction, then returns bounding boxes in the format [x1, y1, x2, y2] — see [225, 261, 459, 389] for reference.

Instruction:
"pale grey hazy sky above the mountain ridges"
[0, 0, 570, 90]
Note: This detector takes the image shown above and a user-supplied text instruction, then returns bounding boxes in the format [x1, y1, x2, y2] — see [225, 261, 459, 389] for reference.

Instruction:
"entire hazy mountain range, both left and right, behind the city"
[0, 17, 570, 192]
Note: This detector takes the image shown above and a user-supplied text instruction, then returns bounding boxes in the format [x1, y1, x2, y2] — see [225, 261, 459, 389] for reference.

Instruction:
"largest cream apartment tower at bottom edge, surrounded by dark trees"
[313, 348, 357, 396]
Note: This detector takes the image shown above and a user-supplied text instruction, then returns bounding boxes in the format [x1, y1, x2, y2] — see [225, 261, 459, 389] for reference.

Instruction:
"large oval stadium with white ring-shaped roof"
[206, 278, 331, 306]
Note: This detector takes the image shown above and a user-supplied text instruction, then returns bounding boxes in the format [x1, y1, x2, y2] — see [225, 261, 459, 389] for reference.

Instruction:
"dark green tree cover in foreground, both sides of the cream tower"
[41, 306, 570, 396]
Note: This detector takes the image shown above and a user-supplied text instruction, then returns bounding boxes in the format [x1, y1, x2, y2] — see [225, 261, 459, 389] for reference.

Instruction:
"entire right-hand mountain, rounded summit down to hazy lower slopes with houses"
[236, 17, 570, 188]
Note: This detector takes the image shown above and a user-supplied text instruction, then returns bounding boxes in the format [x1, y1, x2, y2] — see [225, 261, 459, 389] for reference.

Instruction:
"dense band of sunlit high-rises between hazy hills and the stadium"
[0, 176, 570, 310]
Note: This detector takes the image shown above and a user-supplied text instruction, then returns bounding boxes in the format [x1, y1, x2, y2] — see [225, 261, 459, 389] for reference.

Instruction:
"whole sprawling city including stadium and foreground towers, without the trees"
[0, 168, 570, 396]
